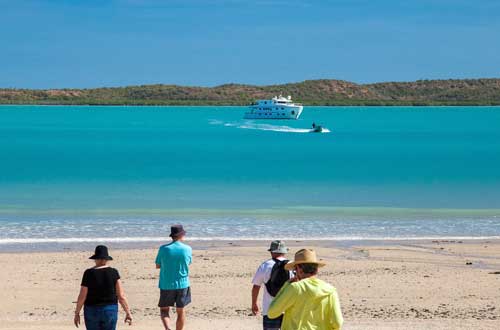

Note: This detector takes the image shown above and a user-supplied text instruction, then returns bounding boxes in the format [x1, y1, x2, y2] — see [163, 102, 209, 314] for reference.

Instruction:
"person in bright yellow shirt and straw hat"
[267, 249, 344, 330]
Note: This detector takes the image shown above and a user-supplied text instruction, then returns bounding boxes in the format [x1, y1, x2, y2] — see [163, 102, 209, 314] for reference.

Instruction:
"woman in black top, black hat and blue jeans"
[74, 245, 132, 330]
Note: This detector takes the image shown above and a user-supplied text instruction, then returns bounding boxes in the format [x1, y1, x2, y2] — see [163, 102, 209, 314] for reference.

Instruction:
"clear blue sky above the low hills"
[0, 0, 500, 88]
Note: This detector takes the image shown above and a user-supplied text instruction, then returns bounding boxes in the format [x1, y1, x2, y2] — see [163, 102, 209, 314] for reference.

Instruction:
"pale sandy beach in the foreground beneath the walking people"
[0, 241, 500, 330]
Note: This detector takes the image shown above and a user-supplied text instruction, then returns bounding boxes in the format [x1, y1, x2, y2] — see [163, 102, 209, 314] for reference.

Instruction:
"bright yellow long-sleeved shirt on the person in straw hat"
[267, 277, 344, 330]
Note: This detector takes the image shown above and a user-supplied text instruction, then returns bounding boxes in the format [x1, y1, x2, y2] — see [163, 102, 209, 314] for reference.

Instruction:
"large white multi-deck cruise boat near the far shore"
[244, 95, 304, 119]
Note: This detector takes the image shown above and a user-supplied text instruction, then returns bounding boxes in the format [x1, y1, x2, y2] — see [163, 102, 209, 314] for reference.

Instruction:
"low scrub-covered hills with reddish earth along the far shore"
[0, 79, 500, 106]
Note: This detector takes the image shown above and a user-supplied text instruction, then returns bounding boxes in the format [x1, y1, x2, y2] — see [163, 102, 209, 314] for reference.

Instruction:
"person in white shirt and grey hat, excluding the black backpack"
[252, 240, 288, 330]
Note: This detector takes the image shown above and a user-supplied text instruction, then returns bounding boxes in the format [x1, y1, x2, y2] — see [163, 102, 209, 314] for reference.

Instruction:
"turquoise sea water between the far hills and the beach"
[0, 106, 500, 242]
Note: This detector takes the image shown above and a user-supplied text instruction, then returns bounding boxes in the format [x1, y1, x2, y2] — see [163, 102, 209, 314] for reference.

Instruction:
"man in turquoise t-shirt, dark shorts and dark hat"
[156, 225, 192, 330]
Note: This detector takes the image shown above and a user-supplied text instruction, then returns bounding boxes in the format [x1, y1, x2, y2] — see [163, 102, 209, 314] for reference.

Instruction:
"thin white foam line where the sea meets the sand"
[0, 236, 500, 245]
